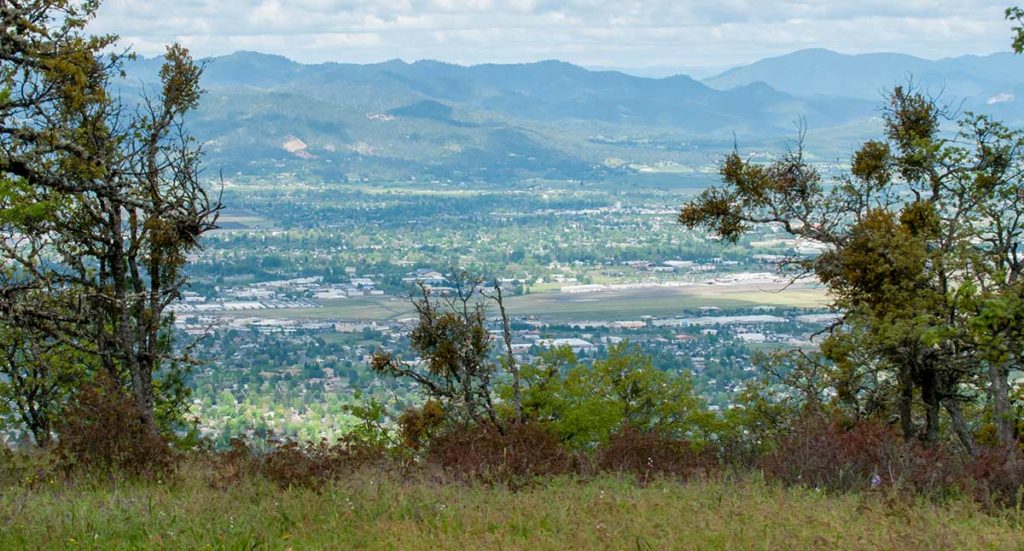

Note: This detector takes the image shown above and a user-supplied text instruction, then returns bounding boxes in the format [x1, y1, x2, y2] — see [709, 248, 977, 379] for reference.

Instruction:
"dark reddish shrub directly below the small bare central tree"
[427, 422, 574, 488]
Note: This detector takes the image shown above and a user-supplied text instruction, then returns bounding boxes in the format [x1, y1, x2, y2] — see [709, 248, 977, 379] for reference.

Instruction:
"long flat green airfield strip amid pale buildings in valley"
[245, 286, 826, 322]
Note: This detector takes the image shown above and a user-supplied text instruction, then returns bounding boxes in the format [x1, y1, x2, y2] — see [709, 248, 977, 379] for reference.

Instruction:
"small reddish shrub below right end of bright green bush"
[597, 426, 718, 483]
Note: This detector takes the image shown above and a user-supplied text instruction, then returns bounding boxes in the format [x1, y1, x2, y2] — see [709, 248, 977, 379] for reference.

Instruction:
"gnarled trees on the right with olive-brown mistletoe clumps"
[679, 87, 1024, 451]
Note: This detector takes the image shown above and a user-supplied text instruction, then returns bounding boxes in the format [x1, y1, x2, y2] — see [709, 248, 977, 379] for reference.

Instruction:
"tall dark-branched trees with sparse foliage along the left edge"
[0, 0, 220, 443]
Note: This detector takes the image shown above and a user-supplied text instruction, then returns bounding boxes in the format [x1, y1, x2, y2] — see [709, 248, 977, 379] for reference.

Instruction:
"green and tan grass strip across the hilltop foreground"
[0, 472, 1024, 550]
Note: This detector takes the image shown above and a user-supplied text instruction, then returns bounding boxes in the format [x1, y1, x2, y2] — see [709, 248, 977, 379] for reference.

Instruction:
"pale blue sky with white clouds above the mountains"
[91, 0, 1024, 73]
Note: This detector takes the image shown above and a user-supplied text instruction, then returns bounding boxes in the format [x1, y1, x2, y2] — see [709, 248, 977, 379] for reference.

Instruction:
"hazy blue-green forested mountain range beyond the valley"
[117, 50, 1024, 181]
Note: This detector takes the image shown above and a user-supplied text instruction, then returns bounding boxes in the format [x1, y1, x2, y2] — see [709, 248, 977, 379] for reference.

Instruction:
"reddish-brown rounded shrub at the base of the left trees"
[56, 374, 176, 476]
